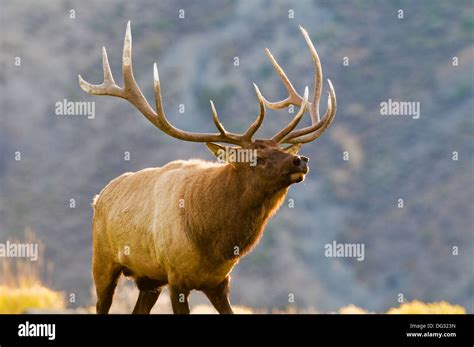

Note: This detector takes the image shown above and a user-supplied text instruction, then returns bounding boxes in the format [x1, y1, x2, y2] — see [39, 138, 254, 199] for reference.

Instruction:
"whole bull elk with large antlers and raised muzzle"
[79, 22, 336, 314]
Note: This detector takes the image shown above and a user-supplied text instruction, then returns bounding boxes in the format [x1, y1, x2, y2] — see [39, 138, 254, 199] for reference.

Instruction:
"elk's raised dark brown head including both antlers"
[79, 22, 336, 188]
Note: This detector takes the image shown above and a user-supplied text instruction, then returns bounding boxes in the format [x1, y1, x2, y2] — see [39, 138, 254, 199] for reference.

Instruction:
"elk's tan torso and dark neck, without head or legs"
[93, 160, 287, 314]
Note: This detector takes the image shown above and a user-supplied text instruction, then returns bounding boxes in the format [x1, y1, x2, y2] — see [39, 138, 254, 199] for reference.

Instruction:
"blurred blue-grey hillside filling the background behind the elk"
[0, 0, 474, 313]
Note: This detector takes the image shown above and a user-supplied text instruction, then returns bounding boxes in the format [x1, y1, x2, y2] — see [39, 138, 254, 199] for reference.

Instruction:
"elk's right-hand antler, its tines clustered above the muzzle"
[264, 26, 337, 144]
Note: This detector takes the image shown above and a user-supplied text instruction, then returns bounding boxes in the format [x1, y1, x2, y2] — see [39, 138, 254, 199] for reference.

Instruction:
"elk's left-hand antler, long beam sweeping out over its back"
[79, 21, 266, 146]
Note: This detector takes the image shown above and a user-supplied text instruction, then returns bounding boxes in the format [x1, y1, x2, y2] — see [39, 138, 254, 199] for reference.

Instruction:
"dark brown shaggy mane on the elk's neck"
[185, 164, 288, 260]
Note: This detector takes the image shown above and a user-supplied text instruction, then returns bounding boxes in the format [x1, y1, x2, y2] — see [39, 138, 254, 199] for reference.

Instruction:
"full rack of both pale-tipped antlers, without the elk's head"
[79, 21, 336, 147]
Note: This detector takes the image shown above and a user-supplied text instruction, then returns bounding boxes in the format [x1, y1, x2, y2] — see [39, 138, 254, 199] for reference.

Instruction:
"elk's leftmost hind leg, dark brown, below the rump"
[93, 265, 121, 314]
